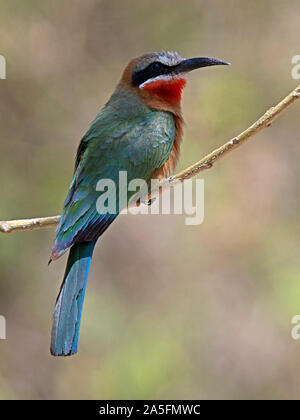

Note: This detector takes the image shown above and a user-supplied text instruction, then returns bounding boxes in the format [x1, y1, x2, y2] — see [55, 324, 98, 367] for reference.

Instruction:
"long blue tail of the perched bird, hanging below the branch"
[50, 241, 96, 356]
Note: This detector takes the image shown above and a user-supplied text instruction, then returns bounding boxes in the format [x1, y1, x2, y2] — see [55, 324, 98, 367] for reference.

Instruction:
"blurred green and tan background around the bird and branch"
[0, 0, 300, 399]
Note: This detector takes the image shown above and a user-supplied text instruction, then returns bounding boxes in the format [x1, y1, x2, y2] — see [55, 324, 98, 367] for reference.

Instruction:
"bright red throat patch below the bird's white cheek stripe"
[143, 77, 186, 104]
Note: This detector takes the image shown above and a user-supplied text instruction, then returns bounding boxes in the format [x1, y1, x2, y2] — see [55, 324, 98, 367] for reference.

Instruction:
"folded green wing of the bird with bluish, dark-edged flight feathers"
[53, 106, 175, 258]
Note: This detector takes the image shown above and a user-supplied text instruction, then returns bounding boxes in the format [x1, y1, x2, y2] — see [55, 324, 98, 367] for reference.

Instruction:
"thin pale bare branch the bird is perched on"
[0, 81, 300, 233]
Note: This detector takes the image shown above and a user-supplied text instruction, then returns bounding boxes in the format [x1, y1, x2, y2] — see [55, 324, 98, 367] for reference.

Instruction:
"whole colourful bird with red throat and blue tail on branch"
[50, 51, 228, 356]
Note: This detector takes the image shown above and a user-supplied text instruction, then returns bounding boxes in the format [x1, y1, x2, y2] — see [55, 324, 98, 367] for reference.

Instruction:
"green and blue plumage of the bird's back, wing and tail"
[51, 82, 175, 356]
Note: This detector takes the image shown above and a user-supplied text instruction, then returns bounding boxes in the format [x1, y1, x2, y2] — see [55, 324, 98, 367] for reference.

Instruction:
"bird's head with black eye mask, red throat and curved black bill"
[120, 51, 228, 113]
